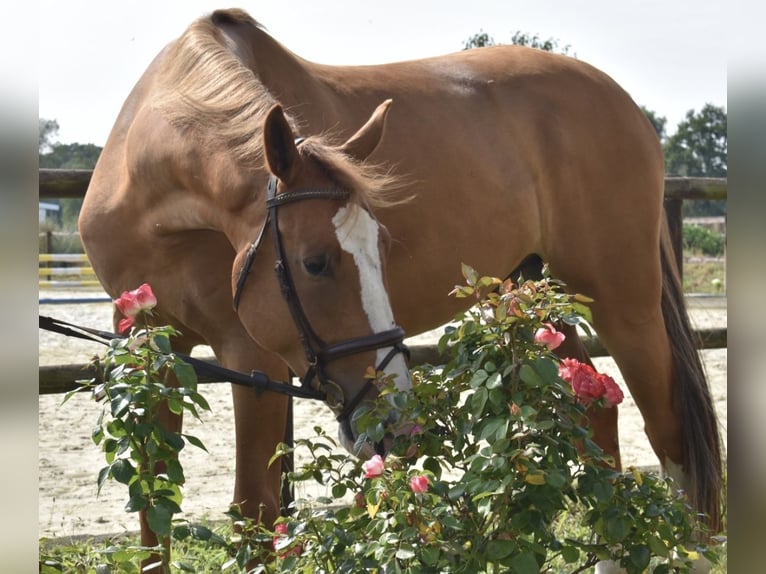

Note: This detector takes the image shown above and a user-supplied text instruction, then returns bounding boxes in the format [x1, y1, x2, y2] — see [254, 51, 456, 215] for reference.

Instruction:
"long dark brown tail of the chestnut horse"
[660, 218, 723, 533]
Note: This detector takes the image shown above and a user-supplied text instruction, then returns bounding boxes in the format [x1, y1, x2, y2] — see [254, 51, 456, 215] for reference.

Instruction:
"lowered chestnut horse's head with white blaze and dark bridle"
[234, 101, 411, 455]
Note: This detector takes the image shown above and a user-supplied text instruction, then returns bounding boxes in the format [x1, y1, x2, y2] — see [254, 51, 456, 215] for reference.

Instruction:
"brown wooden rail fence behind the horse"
[39, 169, 727, 394]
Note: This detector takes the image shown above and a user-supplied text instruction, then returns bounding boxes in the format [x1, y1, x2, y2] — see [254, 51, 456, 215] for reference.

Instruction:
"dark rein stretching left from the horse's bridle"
[40, 315, 327, 401]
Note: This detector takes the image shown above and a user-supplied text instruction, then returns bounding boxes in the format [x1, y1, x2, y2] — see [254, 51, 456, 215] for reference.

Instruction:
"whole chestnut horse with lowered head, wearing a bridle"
[80, 5, 722, 564]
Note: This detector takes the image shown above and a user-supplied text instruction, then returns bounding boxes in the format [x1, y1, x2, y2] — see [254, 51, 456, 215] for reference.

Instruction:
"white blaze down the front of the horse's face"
[332, 203, 411, 390]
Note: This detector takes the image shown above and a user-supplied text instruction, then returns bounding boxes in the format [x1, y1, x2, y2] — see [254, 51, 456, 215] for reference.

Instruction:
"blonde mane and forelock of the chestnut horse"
[152, 10, 402, 207]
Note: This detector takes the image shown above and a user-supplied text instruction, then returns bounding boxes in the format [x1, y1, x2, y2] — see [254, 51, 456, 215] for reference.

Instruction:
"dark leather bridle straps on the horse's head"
[233, 169, 409, 423]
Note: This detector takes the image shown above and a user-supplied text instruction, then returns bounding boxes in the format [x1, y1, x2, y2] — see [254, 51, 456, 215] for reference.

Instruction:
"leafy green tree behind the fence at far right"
[664, 104, 728, 217]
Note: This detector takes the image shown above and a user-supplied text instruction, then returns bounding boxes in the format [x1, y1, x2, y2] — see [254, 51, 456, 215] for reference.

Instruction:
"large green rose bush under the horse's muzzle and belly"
[266, 267, 715, 573]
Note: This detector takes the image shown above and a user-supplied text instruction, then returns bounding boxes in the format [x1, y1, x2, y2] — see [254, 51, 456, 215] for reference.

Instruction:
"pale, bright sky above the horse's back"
[37, 0, 727, 146]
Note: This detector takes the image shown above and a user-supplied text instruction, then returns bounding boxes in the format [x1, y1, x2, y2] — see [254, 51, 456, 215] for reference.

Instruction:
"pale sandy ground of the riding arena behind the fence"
[38, 291, 727, 538]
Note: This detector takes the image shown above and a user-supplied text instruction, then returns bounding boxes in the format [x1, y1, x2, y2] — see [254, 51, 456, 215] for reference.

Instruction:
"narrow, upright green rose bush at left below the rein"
[64, 318, 210, 572]
